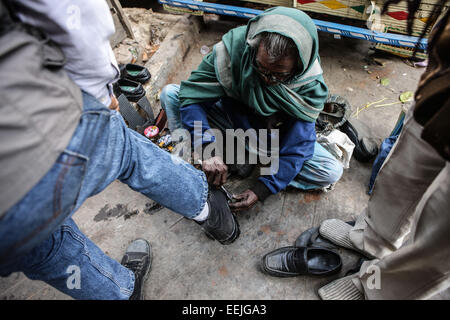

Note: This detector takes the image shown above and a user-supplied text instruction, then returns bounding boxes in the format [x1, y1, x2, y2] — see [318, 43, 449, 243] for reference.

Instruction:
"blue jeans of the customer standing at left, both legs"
[0, 93, 208, 299]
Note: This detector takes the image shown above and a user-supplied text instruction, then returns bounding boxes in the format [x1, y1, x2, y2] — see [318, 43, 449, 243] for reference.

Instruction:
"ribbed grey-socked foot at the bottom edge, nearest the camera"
[318, 274, 364, 300]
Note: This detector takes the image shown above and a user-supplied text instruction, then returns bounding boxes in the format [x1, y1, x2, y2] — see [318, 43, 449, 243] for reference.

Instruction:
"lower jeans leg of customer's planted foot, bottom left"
[19, 218, 135, 300]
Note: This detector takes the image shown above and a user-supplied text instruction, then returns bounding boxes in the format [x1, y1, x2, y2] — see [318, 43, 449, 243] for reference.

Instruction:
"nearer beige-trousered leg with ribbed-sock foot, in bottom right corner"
[319, 162, 450, 300]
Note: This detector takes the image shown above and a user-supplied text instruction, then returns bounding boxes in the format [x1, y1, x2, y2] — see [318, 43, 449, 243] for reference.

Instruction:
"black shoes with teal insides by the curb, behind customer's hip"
[114, 63, 151, 102]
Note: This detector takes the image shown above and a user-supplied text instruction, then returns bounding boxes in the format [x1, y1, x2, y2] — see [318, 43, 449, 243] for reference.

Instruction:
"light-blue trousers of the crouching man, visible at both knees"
[160, 84, 343, 190]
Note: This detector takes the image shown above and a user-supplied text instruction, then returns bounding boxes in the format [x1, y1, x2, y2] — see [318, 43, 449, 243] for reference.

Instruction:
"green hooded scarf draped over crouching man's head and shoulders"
[179, 7, 328, 122]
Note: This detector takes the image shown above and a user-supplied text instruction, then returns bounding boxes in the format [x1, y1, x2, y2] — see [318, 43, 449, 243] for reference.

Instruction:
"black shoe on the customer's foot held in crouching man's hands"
[197, 187, 240, 245]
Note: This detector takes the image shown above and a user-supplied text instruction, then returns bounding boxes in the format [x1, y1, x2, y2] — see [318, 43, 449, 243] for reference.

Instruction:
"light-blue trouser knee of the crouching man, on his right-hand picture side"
[289, 142, 344, 190]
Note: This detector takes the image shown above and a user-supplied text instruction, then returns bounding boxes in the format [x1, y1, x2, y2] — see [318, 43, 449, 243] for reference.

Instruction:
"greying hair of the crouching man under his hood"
[258, 32, 299, 61]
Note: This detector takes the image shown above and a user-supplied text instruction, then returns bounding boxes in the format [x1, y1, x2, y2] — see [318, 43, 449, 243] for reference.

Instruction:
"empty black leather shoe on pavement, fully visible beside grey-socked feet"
[261, 247, 342, 277]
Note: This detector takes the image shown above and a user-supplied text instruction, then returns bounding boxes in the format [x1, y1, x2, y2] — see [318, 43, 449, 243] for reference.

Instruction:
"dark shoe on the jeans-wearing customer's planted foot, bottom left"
[121, 239, 152, 300]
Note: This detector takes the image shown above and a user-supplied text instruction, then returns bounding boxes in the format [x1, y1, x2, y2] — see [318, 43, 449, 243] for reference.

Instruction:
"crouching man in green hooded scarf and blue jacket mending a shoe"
[160, 7, 343, 211]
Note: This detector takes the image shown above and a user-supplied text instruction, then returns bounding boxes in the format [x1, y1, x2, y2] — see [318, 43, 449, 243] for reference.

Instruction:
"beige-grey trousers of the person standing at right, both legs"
[350, 108, 450, 299]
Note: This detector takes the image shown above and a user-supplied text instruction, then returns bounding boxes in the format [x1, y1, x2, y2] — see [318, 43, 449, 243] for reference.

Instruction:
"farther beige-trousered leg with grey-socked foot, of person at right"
[320, 110, 445, 258]
